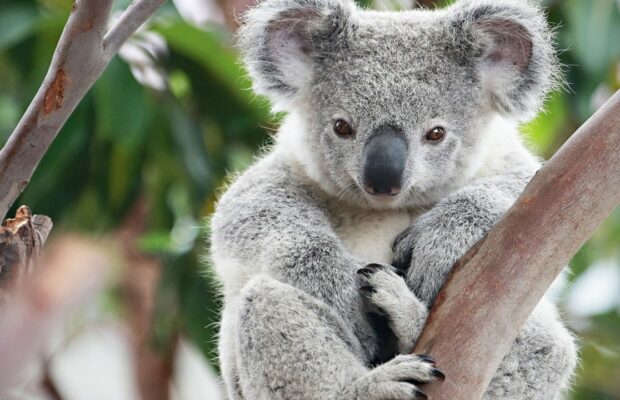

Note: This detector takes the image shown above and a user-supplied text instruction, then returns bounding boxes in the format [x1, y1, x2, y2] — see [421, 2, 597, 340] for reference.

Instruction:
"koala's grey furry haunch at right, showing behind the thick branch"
[484, 299, 577, 400]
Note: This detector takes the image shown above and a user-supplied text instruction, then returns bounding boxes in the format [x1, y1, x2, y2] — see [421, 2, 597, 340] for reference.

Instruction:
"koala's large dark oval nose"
[362, 125, 407, 196]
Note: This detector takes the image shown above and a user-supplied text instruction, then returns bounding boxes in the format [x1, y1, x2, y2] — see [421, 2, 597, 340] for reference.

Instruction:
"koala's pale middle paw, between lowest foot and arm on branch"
[357, 264, 428, 353]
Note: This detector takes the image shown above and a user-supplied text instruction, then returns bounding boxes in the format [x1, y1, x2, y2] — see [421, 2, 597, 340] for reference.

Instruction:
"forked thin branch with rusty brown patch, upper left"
[0, 0, 165, 219]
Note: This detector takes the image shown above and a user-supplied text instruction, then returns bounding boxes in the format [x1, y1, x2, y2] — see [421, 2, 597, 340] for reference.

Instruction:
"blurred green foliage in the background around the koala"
[0, 0, 620, 400]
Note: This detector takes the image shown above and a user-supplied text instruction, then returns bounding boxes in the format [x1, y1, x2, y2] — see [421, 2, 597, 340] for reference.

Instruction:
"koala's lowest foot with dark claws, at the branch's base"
[353, 354, 445, 400]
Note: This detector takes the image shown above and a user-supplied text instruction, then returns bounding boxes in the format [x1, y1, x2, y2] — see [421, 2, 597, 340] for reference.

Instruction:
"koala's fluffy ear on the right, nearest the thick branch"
[453, 0, 559, 120]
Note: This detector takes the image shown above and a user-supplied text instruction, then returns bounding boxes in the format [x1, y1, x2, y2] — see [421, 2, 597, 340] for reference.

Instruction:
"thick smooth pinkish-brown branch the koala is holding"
[415, 92, 620, 399]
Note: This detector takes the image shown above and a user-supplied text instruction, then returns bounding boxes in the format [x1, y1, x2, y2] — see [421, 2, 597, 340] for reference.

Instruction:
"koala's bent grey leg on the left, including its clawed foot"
[236, 277, 444, 400]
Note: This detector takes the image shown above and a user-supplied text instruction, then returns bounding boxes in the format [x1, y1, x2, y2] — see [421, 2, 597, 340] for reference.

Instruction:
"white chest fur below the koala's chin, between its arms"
[330, 207, 415, 264]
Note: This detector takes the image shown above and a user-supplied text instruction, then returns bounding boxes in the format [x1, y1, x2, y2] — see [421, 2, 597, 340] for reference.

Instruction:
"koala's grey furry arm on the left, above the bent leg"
[211, 154, 362, 334]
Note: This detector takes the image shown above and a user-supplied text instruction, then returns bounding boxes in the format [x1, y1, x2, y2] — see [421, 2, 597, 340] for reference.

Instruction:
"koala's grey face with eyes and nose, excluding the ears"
[306, 19, 483, 206]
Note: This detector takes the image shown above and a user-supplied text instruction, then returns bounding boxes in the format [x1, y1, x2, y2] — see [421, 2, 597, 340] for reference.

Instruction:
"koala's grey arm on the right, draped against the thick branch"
[393, 173, 531, 304]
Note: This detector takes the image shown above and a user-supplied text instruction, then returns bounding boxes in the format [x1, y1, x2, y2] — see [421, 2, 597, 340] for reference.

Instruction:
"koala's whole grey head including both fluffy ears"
[240, 0, 557, 207]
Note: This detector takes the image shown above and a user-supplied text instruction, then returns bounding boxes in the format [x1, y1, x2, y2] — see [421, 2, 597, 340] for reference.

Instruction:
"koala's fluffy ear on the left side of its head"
[239, 0, 355, 110]
